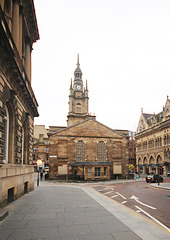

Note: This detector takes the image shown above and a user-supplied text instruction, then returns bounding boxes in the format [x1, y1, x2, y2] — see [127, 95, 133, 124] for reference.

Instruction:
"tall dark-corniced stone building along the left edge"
[0, 0, 39, 206]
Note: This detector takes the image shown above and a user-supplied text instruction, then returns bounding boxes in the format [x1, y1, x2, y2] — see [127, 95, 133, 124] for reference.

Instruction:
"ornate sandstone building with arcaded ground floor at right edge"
[136, 97, 170, 176]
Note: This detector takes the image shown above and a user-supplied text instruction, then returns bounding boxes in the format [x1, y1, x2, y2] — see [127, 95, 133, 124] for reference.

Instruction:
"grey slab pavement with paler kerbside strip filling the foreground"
[0, 177, 170, 240]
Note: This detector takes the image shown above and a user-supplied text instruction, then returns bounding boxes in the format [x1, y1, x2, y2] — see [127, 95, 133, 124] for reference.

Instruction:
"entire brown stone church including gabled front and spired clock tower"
[48, 55, 129, 180]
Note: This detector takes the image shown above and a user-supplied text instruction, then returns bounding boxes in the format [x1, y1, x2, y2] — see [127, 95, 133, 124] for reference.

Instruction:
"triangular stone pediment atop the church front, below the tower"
[50, 119, 125, 139]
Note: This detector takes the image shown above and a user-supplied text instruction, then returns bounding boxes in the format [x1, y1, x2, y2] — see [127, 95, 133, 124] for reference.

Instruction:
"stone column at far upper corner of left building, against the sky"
[25, 38, 31, 81]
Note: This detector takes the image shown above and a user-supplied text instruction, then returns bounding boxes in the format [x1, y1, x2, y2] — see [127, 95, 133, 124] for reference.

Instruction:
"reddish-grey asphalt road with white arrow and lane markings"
[93, 179, 170, 228]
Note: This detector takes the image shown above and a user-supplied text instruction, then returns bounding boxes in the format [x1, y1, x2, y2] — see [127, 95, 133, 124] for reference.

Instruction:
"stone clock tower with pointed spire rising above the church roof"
[67, 54, 95, 127]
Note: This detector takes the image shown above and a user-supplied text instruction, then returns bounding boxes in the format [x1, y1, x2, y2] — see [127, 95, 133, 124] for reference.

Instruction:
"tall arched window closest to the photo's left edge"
[3, 106, 9, 163]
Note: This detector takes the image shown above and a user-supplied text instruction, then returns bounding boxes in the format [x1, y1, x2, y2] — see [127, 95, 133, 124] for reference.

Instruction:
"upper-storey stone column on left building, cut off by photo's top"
[12, 0, 20, 50]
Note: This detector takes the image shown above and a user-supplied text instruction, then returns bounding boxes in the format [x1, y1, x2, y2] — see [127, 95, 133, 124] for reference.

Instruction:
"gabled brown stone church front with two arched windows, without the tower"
[49, 118, 129, 180]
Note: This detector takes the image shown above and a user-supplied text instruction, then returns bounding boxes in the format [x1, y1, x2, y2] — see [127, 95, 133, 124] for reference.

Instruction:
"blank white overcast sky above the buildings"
[32, 0, 170, 131]
